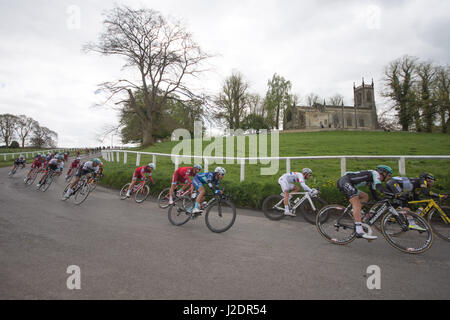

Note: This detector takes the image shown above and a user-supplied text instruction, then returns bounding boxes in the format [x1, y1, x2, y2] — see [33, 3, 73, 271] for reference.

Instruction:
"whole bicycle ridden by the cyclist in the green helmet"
[316, 198, 433, 254]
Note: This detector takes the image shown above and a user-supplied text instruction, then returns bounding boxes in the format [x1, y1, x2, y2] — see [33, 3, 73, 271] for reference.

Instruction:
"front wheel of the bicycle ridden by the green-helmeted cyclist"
[381, 211, 433, 254]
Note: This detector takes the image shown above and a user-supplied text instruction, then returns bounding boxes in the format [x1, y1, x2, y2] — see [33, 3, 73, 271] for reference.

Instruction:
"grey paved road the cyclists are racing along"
[0, 168, 450, 299]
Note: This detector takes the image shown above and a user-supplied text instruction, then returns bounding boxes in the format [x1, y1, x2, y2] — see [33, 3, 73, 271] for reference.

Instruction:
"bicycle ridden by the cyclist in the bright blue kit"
[168, 190, 236, 233]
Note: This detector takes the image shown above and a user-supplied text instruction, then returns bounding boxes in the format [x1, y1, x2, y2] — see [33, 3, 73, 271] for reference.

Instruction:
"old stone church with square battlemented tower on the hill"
[284, 79, 379, 130]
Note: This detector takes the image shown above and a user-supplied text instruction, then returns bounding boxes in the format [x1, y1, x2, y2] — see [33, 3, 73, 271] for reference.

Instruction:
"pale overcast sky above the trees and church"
[0, 0, 450, 147]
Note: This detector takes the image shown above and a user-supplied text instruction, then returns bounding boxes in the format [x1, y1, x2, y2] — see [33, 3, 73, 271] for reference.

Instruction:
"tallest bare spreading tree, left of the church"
[84, 6, 210, 145]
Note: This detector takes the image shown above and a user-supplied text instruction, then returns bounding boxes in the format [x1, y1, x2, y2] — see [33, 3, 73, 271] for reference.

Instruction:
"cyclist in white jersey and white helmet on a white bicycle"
[278, 168, 319, 217]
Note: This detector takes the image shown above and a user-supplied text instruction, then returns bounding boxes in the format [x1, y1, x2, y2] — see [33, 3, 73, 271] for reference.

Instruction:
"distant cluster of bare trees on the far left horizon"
[0, 113, 58, 148]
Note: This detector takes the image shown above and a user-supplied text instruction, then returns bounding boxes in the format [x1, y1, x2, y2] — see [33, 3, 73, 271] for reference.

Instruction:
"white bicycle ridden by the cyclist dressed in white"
[262, 192, 328, 224]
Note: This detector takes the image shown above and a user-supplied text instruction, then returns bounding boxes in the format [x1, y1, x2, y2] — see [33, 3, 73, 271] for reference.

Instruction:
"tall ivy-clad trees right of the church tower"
[383, 56, 450, 133]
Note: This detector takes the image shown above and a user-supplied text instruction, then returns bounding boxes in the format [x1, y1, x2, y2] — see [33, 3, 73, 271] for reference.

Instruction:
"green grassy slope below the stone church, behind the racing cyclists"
[99, 131, 450, 207]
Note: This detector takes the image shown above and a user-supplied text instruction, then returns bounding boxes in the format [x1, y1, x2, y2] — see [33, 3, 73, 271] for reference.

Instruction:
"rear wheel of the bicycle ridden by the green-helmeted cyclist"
[316, 205, 356, 245]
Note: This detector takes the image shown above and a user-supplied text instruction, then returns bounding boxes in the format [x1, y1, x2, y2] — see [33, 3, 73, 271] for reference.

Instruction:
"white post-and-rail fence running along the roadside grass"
[102, 150, 450, 181]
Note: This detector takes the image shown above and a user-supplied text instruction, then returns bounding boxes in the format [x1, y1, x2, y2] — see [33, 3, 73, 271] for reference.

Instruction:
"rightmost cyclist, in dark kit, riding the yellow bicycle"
[387, 173, 447, 231]
